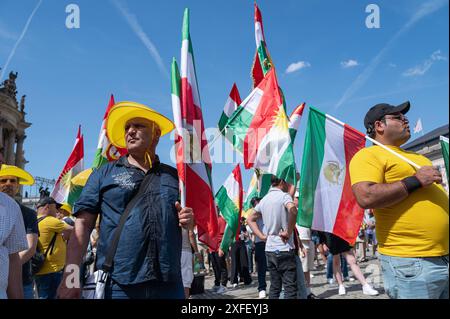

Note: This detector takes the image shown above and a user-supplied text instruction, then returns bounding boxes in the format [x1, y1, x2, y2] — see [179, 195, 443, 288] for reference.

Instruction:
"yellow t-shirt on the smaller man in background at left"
[37, 216, 68, 275]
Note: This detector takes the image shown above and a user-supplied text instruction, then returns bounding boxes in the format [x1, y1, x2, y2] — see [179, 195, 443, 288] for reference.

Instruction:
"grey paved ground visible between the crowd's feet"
[191, 257, 388, 299]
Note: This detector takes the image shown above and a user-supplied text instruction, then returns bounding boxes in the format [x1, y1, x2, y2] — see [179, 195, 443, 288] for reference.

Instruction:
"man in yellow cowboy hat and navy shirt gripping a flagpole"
[59, 102, 194, 299]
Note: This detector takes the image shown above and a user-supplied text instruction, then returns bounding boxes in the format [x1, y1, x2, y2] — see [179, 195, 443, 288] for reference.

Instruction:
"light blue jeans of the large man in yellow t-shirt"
[379, 254, 449, 299]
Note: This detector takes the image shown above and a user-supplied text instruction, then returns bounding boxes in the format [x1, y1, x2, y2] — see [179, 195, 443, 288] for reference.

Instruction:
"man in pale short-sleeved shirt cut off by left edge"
[0, 146, 28, 299]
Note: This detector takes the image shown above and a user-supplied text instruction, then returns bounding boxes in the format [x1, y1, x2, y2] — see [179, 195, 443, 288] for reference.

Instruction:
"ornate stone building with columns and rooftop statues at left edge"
[0, 72, 31, 168]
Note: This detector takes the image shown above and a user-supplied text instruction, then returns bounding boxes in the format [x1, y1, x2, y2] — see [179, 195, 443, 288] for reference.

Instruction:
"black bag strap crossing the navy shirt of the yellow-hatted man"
[102, 172, 152, 273]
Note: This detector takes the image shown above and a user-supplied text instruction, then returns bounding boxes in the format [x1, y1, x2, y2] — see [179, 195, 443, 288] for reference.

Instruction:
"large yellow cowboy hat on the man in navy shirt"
[106, 102, 175, 148]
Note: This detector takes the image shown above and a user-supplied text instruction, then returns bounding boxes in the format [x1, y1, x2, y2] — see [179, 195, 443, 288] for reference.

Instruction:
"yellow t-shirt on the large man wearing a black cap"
[350, 146, 449, 257]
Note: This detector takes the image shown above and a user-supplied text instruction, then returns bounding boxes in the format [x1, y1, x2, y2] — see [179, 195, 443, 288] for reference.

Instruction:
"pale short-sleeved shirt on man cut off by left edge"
[0, 193, 28, 299]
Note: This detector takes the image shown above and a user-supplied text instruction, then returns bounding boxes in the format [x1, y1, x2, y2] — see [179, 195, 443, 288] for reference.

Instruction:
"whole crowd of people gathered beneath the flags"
[0, 102, 449, 299]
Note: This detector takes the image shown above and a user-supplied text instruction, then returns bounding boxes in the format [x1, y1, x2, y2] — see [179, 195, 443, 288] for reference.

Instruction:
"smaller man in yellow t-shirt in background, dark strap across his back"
[36, 197, 73, 299]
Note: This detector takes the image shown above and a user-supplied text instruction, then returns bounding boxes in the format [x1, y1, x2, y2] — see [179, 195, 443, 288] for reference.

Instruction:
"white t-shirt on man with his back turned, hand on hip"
[255, 187, 295, 252]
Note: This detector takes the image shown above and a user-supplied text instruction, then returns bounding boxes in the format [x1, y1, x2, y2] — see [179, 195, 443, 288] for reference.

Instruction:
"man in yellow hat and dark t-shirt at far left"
[0, 165, 39, 299]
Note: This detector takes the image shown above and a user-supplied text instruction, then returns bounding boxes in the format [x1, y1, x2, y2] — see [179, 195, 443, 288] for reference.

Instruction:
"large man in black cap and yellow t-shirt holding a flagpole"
[350, 102, 449, 299]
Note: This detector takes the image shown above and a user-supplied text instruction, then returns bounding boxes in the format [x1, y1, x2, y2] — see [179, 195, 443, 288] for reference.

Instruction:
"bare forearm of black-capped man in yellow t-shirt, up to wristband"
[353, 182, 408, 209]
